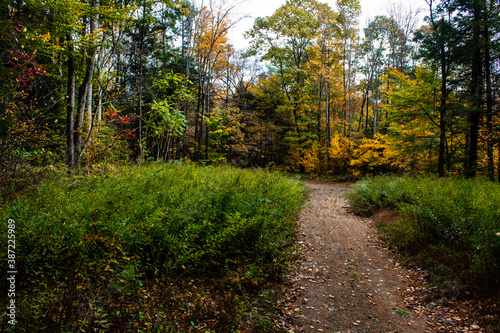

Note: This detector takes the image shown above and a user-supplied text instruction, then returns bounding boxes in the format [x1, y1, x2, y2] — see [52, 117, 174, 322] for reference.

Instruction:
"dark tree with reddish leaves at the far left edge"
[0, 2, 51, 182]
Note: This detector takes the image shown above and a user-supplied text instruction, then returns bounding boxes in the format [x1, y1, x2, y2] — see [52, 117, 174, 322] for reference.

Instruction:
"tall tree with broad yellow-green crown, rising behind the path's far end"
[247, 0, 336, 172]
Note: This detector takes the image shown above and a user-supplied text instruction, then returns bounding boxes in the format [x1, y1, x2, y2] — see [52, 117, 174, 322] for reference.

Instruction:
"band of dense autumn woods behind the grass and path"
[0, 0, 500, 187]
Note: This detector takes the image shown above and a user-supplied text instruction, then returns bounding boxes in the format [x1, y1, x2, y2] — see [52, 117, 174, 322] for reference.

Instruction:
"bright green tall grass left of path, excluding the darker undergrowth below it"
[0, 164, 304, 327]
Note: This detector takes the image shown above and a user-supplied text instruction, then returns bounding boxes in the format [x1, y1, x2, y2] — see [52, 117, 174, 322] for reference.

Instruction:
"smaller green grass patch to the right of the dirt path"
[350, 176, 500, 290]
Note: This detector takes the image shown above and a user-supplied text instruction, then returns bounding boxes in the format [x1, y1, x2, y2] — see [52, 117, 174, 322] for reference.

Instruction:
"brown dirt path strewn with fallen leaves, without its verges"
[289, 183, 427, 333]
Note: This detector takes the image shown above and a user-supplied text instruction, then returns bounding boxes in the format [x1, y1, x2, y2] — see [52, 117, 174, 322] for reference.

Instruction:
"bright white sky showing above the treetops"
[229, 0, 428, 50]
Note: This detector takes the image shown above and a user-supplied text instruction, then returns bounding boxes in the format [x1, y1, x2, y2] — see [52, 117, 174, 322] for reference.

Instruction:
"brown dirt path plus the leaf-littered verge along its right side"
[283, 182, 496, 333]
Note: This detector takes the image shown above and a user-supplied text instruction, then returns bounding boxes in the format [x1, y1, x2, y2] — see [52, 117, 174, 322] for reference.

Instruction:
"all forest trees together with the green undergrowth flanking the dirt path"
[0, 0, 500, 332]
